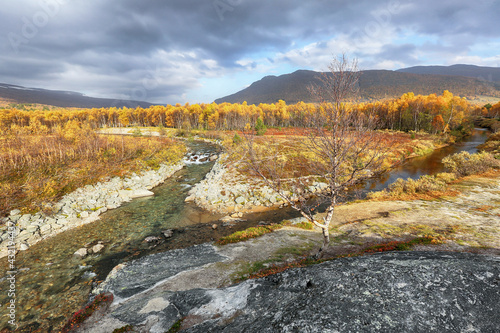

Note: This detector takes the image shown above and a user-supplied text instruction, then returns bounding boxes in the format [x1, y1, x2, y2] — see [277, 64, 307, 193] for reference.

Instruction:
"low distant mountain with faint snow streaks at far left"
[0, 83, 152, 108]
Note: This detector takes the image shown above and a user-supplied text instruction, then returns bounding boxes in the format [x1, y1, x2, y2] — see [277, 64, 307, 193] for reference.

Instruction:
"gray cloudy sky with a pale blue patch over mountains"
[0, 0, 500, 104]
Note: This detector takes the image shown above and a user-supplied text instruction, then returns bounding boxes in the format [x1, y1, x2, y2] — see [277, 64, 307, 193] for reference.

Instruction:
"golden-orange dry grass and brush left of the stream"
[0, 122, 185, 216]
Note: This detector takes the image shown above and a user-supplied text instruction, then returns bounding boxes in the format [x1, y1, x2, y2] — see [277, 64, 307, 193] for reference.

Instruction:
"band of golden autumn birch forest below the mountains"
[0, 91, 500, 134]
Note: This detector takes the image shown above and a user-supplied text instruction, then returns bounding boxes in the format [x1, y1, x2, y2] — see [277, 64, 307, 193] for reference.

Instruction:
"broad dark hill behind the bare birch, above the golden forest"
[215, 70, 500, 104]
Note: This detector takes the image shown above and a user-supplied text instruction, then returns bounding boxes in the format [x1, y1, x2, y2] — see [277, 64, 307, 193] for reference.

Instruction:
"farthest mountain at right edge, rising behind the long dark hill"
[397, 65, 500, 83]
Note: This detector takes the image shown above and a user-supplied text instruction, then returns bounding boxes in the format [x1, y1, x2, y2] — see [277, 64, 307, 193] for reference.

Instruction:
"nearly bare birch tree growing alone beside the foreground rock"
[247, 55, 387, 257]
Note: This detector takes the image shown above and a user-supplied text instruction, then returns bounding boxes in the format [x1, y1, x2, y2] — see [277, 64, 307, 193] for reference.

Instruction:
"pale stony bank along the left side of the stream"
[0, 161, 185, 258]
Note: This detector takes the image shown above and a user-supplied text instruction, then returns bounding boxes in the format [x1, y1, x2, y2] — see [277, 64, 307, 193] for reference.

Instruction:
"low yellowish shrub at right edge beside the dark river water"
[443, 151, 500, 177]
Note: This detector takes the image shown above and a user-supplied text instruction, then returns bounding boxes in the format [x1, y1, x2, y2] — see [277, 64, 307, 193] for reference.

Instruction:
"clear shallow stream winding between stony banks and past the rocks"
[0, 129, 487, 332]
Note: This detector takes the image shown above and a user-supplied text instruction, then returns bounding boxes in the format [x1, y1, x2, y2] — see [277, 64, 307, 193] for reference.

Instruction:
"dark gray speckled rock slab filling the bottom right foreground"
[99, 252, 500, 333]
